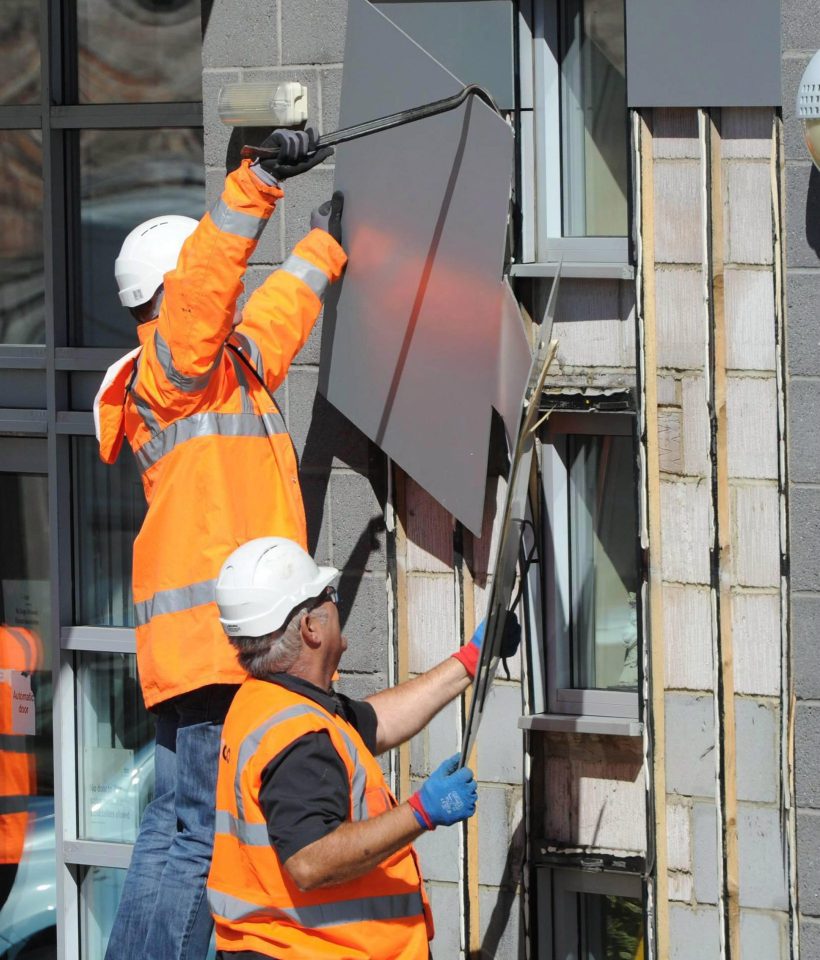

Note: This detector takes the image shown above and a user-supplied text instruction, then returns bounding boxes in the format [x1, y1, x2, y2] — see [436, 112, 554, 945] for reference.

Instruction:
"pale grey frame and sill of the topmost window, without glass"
[511, 0, 634, 279]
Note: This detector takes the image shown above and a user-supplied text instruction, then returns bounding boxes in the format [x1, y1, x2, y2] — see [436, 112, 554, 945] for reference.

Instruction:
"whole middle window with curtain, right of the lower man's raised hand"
[541, 413, 641, 718]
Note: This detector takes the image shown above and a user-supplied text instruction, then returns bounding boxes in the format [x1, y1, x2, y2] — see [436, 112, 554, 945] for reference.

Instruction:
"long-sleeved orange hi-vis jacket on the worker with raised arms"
[94, 161, 347, 707]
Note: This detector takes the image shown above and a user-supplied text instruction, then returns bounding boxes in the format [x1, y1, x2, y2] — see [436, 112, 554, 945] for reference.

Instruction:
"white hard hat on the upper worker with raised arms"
[114, 216, 198, 307]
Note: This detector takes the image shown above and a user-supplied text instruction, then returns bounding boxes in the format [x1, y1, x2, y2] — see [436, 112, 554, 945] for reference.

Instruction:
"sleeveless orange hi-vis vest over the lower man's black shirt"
[208, 680, 433, 960]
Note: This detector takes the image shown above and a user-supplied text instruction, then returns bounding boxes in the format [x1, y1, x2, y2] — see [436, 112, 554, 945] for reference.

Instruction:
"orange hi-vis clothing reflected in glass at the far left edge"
[0, 623, 43, 909]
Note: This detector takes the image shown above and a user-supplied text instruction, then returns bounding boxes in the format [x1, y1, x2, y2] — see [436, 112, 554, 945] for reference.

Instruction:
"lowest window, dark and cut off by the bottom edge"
[538, 868, 644, 960]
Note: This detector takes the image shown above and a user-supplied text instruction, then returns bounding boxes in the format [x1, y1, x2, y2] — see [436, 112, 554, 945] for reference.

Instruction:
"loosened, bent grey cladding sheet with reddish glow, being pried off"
[320, 0, 530, 535]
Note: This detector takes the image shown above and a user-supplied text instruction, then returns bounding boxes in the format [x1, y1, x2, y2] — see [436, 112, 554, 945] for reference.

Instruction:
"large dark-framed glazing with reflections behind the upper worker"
[0, 0, 205, 960]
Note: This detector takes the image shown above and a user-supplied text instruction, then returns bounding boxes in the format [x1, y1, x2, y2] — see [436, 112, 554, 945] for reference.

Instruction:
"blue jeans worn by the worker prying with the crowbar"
[105, 685, 237, 960]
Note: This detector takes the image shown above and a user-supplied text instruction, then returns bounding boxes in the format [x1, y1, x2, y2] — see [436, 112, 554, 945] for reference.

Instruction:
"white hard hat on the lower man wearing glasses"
[216, 537, 339, 637]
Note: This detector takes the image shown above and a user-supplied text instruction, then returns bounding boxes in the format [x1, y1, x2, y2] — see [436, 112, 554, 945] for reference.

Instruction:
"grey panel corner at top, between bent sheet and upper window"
[374, 0, 515, 110]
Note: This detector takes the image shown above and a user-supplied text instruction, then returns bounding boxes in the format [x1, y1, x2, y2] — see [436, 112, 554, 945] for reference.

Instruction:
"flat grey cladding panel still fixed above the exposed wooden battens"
[626, 0, 780, 107]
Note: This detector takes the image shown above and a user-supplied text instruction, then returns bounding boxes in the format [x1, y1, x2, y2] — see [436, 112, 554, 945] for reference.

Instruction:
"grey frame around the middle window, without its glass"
[538, 412, 644, 720]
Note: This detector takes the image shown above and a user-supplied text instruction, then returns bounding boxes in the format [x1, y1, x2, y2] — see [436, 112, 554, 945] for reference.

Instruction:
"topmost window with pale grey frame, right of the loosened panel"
[514, 0, 631, 277]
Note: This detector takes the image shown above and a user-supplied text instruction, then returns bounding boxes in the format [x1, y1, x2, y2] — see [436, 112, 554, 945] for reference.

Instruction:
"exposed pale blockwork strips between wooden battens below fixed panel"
[651, 109, 789, 960]
